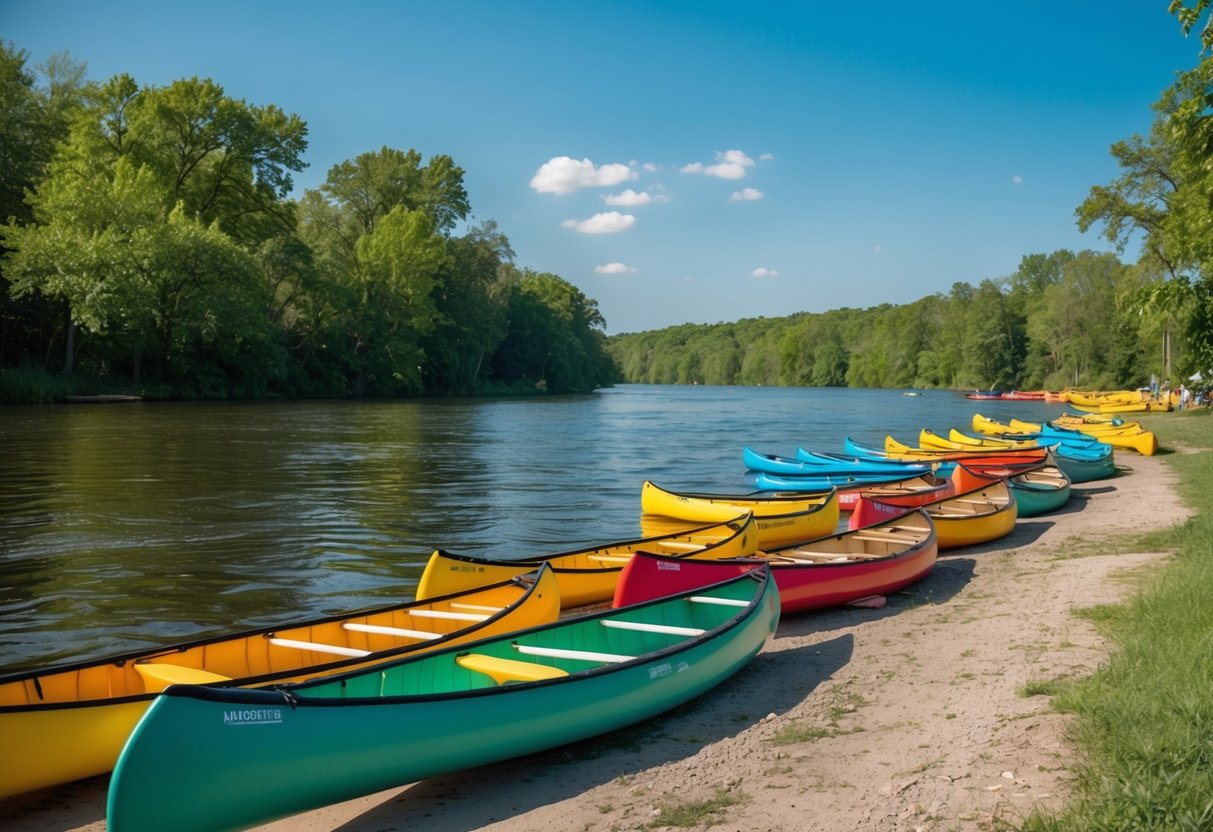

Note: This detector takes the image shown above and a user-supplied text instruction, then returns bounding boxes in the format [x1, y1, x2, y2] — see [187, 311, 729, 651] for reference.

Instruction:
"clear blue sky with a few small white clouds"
[0, 0, 1198, 334]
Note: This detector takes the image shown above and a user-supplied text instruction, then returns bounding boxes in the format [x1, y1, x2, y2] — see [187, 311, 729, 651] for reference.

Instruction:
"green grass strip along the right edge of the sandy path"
[1021, 411, 1213, 832]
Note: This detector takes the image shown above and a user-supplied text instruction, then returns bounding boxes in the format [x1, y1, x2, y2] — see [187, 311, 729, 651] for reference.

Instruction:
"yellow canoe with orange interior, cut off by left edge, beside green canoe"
[0, 569, 560, 797]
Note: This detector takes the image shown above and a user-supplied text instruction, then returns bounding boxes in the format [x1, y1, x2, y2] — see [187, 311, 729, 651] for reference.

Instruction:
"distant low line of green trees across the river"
[610, 251, 1207, 389]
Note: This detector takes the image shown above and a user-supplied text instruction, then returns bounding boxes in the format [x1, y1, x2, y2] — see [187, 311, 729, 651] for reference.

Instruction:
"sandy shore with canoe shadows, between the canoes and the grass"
[0, 451, 1186, 832]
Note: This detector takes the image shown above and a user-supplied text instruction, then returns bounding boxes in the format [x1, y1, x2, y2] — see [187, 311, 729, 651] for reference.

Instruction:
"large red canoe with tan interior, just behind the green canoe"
[611, 512, 939, 615]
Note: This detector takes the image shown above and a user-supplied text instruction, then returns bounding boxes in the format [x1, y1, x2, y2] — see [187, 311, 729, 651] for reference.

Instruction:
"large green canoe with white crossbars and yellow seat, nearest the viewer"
[107, 566, 779, 832]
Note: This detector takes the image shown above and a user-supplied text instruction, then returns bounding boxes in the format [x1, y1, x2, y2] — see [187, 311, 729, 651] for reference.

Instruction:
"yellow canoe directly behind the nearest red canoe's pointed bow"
[417, 511, 758, 609]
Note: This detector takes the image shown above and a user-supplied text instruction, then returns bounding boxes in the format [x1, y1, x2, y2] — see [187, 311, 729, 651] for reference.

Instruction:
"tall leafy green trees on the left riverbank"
[0, 42, 616, 401]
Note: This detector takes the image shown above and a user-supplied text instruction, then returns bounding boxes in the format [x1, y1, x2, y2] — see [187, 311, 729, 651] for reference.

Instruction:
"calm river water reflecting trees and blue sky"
[0, 384, 1059, 669]
